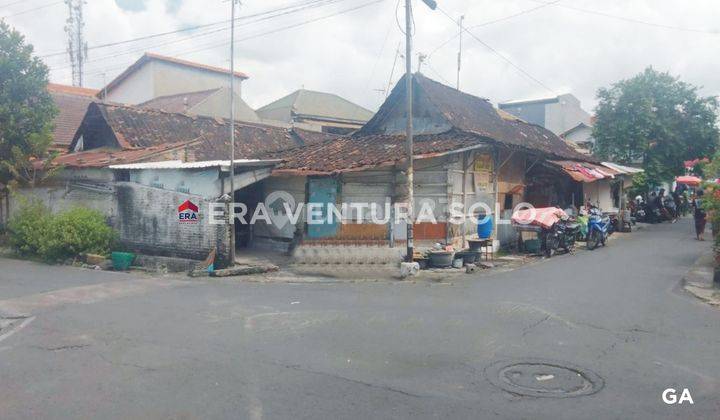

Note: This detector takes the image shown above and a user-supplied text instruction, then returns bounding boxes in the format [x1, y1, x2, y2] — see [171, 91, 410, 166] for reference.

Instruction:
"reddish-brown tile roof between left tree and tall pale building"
[47, 83, 97, 148]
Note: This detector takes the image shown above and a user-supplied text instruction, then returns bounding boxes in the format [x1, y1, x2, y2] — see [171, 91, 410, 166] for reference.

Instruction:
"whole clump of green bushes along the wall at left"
[8, 203, 115, 261]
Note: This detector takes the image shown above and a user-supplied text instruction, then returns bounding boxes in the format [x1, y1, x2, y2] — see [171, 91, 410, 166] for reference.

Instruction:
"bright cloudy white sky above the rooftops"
[5, 0, 720, 110]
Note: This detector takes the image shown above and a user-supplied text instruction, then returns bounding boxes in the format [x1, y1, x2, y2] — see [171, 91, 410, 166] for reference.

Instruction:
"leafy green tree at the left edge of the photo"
[0, 21, 57, 185]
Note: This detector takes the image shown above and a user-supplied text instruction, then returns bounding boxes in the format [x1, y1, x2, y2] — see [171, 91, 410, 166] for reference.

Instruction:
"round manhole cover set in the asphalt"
[485, 359, 604, 398]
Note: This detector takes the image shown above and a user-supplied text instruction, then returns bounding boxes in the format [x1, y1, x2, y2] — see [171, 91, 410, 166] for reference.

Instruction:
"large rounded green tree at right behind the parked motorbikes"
[593, 67, 719, 185]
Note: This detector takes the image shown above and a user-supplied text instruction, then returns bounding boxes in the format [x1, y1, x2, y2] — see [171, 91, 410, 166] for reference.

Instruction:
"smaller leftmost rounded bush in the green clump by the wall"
[7, 201, 51, 256]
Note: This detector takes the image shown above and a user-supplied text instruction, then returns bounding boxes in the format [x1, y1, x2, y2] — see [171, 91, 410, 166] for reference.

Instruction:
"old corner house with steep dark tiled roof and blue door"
[255, 73, 588, 253]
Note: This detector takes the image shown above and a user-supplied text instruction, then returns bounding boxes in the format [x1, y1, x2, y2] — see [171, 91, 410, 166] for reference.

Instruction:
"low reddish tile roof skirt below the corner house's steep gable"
[259, 131, 485, 174]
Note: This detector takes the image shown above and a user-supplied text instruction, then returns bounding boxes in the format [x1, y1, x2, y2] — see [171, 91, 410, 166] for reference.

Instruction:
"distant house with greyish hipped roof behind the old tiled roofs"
[257, 89, 373, 134]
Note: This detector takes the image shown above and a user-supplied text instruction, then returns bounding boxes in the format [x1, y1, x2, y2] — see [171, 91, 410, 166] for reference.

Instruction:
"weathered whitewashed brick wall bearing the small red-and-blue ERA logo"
[115, 182, 230, 260]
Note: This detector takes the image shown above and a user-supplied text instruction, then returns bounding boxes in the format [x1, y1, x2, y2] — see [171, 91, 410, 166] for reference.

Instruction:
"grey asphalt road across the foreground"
[0, 220, 720, 419]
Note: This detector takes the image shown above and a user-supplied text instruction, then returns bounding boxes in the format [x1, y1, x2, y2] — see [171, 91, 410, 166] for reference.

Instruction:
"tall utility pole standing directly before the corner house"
[405, 0, 415, 262]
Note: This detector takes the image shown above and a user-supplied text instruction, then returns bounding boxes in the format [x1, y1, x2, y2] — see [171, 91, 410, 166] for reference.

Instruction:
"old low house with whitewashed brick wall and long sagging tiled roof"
[10, 102, 336, 266]
